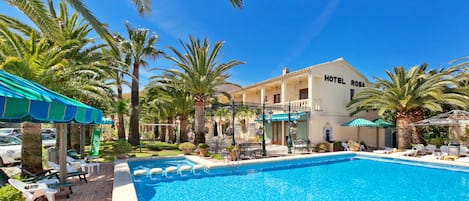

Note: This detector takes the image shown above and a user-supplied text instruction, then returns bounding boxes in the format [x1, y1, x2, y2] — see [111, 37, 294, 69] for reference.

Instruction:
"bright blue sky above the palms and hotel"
[0, 0, 469, 92]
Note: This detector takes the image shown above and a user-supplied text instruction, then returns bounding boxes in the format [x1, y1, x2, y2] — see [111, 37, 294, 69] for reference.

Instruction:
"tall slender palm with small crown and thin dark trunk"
[122, 23, 163, 146]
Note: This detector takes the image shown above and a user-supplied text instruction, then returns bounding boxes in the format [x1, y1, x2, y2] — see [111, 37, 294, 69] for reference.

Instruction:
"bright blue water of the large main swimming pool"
[129, 155, 469, 201]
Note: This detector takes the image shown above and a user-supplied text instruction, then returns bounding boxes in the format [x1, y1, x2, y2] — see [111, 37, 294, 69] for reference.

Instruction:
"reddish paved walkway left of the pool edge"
[55, 162, 114, 201]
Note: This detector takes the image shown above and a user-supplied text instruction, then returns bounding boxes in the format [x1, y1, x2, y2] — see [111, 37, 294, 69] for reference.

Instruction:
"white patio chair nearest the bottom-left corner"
[8, 179, 57, 201]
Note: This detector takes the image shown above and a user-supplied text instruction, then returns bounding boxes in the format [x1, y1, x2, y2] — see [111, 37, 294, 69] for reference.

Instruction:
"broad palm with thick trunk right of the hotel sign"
[347, 65, 469, 149]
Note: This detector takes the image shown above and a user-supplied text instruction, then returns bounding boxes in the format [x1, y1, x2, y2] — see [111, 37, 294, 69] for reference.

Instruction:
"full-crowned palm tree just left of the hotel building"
[167, 36, 243, 144]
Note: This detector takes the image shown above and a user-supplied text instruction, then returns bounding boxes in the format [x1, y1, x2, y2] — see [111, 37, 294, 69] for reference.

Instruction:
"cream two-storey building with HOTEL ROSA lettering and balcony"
[216, 58, 392, 147]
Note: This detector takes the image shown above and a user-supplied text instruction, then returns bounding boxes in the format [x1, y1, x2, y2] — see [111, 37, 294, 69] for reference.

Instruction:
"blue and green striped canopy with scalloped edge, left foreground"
[0, 70, 103, 124]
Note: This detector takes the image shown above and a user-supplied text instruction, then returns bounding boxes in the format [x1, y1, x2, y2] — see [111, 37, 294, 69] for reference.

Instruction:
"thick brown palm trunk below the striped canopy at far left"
[21, 123, 43, 173]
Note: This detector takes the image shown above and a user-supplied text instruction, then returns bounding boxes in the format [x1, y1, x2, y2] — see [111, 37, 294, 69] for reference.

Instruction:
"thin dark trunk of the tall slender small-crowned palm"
[129, 61, 140, 146]
